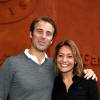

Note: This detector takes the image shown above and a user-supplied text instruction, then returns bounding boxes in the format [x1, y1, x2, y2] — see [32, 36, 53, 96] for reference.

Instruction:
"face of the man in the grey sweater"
[30, 21, 54, 51]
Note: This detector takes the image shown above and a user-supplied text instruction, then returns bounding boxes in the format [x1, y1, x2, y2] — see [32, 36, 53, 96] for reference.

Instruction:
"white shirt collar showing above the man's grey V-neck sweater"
[24, 49, 48, 64]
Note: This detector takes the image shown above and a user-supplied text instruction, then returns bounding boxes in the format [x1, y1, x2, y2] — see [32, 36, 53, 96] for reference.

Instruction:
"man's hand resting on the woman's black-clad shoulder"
[83, 69, 97, 81]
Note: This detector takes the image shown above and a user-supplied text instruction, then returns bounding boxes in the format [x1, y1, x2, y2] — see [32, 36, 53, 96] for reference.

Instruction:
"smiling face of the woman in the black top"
[57, 46, 75, 73]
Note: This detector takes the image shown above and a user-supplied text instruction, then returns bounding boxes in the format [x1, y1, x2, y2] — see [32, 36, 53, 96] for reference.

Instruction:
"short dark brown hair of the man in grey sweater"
[30, 16, 56, 37]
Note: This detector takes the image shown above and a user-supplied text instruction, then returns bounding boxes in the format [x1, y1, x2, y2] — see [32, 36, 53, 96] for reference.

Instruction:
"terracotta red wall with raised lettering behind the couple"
[0, 0, 100, 92]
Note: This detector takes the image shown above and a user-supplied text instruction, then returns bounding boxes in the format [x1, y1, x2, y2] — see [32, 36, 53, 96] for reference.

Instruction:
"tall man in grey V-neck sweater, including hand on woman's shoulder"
[0, 17, 96, 100]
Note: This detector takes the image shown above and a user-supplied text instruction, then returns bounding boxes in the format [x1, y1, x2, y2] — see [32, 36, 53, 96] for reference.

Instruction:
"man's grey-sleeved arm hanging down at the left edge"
[0, 60, 12, 100]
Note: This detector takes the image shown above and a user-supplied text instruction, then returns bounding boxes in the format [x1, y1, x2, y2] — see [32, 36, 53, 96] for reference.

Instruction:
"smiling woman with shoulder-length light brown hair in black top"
[52, 40, 99, 100]
